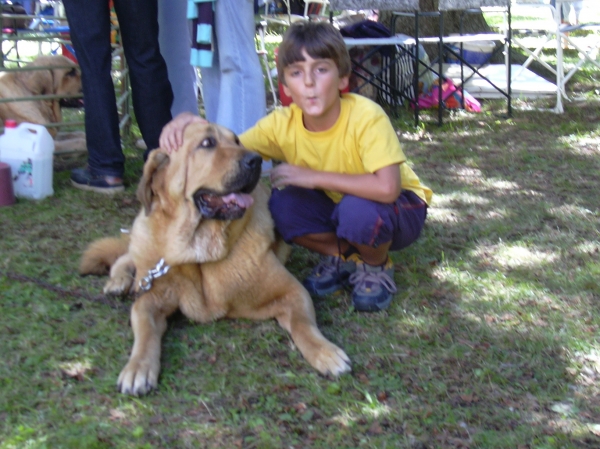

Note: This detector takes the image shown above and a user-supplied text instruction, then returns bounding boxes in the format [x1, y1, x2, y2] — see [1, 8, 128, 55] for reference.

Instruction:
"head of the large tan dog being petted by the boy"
[138, 123, 262, 220]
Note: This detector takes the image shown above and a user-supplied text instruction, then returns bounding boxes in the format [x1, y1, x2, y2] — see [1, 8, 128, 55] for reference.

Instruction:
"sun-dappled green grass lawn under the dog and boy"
[0, 30, 600, 449]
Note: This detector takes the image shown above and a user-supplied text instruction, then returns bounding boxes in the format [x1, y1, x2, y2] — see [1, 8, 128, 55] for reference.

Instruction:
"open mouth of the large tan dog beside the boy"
[194, 190, 254, 220]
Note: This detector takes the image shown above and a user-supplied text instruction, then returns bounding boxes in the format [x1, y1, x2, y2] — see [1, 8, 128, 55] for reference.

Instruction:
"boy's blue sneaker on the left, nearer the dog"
[302, 254, 360, 296]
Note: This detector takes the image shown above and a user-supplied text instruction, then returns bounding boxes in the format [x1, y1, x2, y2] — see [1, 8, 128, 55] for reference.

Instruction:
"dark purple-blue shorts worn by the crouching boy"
[269, 186, 427, 250]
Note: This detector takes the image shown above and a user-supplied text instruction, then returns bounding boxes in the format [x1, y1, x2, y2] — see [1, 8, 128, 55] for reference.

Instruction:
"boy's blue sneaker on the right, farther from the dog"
[349, 256, 398, 312]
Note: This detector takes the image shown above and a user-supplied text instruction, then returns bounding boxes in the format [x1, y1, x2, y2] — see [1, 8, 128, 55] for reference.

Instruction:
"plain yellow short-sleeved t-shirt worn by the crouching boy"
[240, 94, 432, 204]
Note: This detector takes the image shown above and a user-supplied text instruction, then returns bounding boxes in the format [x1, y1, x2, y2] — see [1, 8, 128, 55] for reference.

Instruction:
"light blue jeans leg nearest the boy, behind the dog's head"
[201, 0, 267, 134]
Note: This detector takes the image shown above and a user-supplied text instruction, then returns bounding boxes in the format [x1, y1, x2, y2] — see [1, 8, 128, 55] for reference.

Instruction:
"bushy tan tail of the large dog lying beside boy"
[79, 235, 129, 276]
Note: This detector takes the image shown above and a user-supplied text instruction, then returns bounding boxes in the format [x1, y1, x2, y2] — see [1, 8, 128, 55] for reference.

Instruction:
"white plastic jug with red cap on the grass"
[0, 120, 54, 200]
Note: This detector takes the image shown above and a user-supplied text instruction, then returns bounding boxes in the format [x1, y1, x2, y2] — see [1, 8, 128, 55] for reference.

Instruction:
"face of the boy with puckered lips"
[283, 50, 348, 131]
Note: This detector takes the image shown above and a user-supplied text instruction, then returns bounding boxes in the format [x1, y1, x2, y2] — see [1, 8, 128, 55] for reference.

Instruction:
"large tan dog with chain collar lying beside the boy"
[80, 123, 350, 395]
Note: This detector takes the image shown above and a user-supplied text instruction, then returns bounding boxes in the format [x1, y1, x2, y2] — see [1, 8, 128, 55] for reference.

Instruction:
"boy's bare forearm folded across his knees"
[271, 164, 401, 203]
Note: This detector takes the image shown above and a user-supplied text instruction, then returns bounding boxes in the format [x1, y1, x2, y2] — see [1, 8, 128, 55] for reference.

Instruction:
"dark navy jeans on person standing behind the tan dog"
[63, 0, 173, 177]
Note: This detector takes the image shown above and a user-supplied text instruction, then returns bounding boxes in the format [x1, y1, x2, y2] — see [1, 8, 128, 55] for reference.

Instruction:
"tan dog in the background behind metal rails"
[0, 55, 86, 153]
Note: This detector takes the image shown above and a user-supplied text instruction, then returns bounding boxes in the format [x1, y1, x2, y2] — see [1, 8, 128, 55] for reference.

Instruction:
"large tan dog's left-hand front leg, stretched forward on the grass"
[118, 293, 176, 396]
